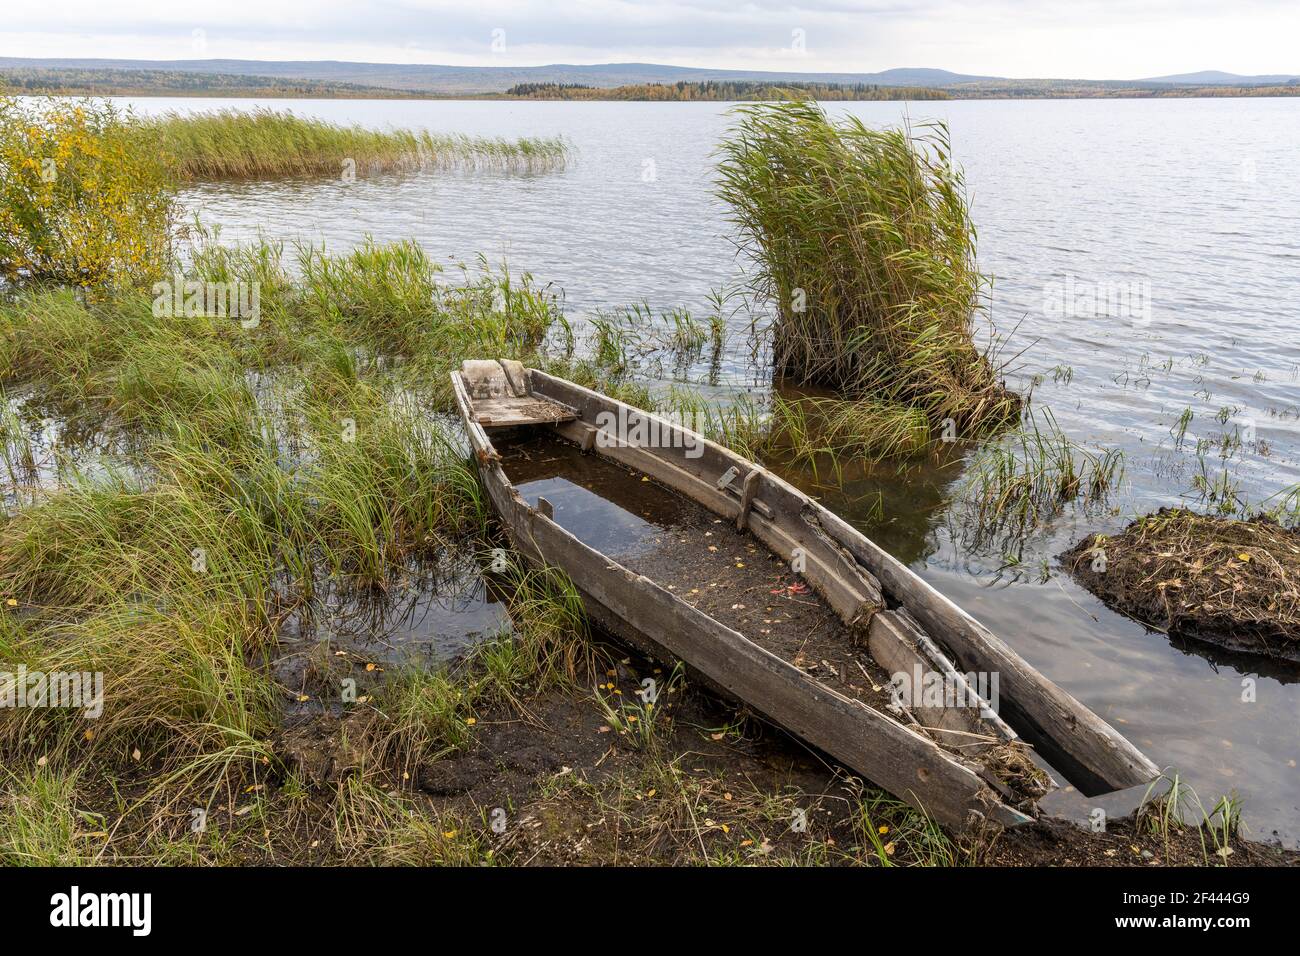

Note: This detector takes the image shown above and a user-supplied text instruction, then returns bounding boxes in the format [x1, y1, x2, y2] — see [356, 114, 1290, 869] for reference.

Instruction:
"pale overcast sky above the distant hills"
[0, 0, 1300, 79]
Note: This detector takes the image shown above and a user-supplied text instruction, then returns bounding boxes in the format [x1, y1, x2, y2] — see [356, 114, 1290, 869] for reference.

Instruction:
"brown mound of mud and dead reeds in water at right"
[1061, 509, 1300, 663]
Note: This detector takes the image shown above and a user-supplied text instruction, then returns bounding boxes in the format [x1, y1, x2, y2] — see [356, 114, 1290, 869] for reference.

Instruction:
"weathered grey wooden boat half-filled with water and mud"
[451, 360, 1158, 829]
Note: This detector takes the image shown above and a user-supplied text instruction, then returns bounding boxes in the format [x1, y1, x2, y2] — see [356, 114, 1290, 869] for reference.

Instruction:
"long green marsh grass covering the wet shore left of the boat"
[0, 232, 618, 861]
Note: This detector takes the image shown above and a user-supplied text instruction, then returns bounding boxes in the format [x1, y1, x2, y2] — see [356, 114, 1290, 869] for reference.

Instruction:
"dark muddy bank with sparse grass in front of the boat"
[103, 671, 1300, 868]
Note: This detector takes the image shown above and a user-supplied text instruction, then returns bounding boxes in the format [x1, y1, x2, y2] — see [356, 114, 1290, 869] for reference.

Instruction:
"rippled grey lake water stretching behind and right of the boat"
[124, 99, 1300, 845]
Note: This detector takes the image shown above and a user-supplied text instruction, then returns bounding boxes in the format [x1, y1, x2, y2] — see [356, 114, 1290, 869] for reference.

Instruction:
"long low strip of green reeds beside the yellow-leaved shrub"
[140, 109, 568, 182]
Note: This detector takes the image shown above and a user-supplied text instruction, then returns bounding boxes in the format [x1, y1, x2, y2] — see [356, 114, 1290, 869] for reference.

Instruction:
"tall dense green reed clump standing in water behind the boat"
[719, 101, 1021, 447]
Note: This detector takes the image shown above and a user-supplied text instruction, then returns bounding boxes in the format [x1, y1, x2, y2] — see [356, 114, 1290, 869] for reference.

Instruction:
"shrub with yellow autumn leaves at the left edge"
[0, 95, 176, 287]
